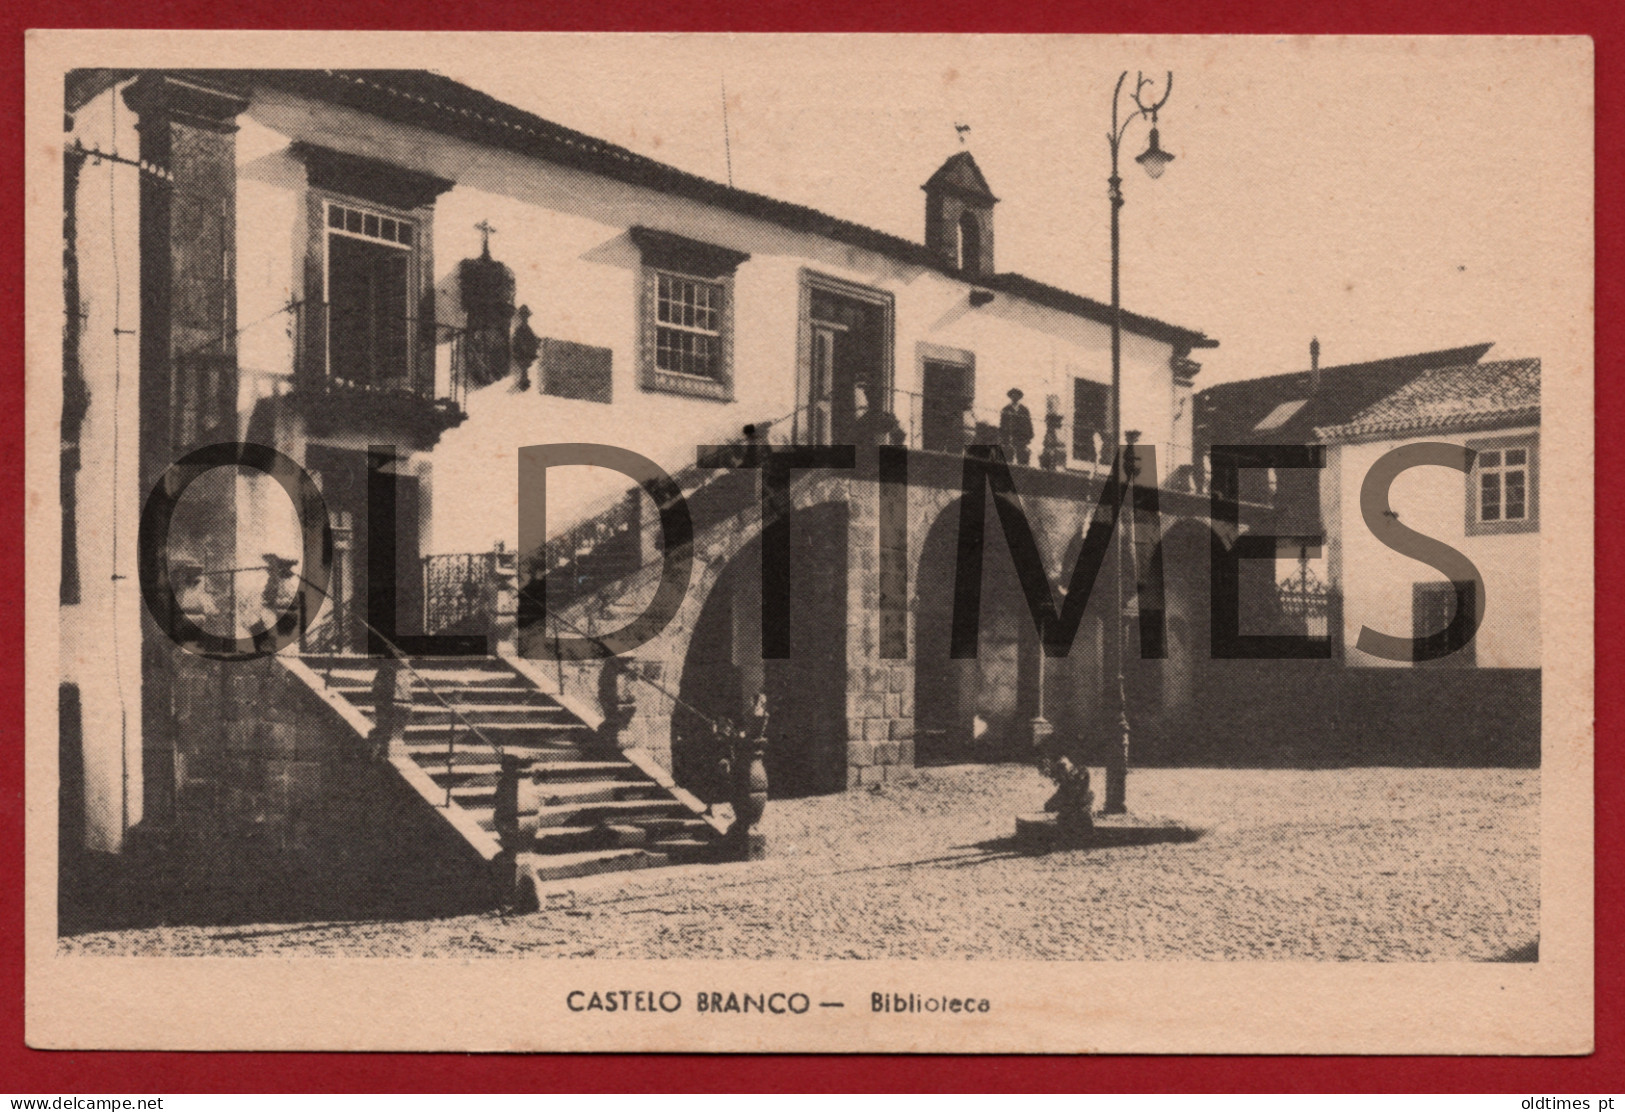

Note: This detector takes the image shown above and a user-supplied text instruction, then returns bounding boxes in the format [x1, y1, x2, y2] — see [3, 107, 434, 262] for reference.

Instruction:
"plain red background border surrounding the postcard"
[0, 0, 1625, 1094]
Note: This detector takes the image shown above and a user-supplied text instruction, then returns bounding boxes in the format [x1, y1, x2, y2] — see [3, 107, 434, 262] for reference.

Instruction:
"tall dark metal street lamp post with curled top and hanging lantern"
[1103, 70, 1173, 814]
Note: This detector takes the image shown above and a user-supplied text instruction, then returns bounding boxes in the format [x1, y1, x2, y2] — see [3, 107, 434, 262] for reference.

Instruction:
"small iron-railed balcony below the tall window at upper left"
[288, 302, 470, 450]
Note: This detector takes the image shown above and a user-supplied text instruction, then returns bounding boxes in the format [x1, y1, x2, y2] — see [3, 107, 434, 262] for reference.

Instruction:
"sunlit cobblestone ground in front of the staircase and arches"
[62, 766, 1541, 961]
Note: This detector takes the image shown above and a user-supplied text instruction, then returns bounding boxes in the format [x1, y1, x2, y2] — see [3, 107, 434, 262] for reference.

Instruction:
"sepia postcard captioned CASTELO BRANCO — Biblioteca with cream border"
[26, 31, 1593, 1055]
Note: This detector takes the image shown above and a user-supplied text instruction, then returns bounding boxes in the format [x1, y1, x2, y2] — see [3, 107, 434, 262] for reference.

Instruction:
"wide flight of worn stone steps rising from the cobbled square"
[280, 655, 726, 902]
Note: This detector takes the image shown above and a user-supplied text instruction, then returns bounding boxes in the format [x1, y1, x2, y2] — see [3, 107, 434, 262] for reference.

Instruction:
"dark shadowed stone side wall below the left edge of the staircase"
[153, 649, 492, 922]
